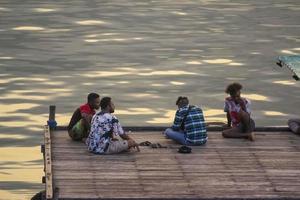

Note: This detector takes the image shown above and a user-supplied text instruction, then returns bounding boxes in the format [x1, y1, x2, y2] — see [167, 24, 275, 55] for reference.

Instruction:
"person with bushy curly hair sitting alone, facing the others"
[222, 83, 255, 141]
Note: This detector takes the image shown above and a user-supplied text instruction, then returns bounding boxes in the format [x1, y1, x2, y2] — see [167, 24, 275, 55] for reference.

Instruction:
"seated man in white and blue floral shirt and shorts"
[86, 97, 139, 154]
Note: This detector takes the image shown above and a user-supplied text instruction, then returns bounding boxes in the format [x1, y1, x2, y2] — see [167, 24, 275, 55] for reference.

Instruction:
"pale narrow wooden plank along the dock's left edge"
[44, 126, 53, 199]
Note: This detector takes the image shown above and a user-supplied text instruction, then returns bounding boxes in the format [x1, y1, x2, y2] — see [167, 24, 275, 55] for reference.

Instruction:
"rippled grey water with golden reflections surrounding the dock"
[0, 0, 300, 199]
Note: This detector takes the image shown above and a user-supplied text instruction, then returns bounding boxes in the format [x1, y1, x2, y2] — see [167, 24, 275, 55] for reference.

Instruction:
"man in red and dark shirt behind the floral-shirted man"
[68, 93, 100, 141]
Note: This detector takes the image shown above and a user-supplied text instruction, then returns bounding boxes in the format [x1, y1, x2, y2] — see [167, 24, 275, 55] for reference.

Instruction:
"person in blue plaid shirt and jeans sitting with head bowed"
[164, 96, 207, 146]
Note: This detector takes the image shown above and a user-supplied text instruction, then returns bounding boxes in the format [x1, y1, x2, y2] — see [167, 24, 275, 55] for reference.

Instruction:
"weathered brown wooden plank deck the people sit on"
[51, 131, 300, 199]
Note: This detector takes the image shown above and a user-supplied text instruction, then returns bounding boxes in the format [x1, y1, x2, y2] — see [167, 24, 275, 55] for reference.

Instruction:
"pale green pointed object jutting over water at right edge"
[277, 55, 300, 81]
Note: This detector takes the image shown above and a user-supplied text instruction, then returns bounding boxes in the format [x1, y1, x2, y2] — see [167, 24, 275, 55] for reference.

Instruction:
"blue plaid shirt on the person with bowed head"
[172, 105, 207, 144]
